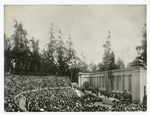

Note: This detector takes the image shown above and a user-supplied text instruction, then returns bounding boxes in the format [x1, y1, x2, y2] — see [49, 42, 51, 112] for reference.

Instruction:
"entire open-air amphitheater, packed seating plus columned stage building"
[4, 58, 147, 112]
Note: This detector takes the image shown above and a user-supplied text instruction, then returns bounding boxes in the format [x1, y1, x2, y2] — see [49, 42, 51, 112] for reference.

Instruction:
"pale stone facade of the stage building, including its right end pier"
[78, 67, 147, 102]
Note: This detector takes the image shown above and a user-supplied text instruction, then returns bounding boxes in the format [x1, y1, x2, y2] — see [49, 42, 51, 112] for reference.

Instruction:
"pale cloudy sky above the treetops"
[4, 5, 147, 65]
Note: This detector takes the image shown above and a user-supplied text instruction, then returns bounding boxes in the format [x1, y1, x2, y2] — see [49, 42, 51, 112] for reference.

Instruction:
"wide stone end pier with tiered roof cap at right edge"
[130, 57, 147, 102]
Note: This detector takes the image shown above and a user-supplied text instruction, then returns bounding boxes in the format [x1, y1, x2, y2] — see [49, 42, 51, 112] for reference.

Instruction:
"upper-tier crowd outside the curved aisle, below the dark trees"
[4, 75, 71, 112]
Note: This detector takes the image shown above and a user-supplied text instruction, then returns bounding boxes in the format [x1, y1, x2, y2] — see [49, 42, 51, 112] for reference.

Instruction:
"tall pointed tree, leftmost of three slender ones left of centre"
[41, 23, 58, 75]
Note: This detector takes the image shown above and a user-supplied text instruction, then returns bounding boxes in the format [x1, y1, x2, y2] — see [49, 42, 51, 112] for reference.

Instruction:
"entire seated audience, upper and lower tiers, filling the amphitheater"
[4, 76, 147, 112]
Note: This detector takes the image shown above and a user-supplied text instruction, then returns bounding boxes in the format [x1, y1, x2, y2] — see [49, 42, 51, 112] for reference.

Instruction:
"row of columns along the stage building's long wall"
[79, 74, 132, 92]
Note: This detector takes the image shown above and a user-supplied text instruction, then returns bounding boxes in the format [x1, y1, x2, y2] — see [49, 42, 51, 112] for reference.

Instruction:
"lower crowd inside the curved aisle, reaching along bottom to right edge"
[22, 88, 147, 112]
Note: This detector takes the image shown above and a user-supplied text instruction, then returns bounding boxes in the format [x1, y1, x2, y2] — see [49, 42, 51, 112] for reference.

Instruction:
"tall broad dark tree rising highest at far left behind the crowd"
[11, 20, 30, 72]
